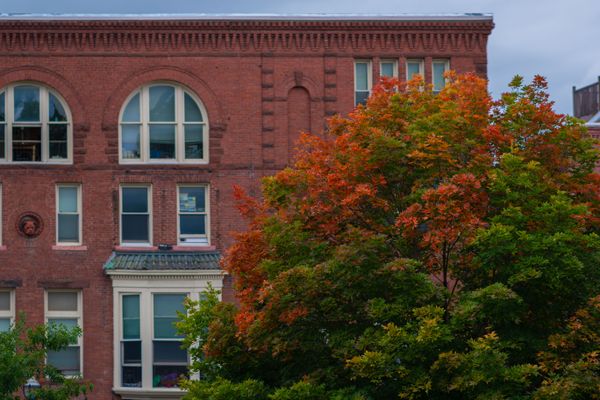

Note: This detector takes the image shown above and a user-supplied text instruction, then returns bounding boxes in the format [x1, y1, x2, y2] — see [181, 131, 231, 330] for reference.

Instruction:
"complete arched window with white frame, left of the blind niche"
[119, 83, 208, 164]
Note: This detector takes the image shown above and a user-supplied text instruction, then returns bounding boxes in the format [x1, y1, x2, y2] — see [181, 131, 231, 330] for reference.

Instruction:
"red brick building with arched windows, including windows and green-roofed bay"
[0, 14, 493, 399]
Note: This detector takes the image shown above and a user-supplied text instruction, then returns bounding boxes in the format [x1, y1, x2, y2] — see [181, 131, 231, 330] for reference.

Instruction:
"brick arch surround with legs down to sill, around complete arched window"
[102, 66, 226, 164]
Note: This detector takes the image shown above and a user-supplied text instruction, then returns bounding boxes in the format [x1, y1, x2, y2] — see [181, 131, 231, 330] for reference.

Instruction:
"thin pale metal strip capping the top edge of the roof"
[0, 13, 494, 21]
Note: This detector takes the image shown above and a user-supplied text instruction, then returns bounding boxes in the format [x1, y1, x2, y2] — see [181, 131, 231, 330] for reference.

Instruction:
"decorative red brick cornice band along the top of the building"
[0, 20, 493, 54]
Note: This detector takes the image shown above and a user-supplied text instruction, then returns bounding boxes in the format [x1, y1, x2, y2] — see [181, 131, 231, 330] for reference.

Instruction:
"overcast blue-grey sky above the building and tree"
[0, 0, 600, 113]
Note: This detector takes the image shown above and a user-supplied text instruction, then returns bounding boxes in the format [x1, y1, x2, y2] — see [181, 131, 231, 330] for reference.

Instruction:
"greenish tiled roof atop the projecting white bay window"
[104, 251, 221, 271]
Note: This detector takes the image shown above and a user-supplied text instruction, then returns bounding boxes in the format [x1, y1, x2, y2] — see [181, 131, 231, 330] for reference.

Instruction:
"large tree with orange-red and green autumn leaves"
[181, 74, 600, 399]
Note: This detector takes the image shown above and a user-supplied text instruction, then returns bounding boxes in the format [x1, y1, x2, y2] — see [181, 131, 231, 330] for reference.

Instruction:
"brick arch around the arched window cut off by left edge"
[0, 65, 90, 164]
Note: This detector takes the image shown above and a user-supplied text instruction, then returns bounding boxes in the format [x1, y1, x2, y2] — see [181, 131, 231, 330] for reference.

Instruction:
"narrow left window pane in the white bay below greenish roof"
[121, 294, 142, 387]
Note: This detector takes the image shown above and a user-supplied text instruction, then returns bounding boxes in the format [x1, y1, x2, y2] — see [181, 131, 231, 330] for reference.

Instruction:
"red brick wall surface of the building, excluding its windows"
[0, 16, 493, 400]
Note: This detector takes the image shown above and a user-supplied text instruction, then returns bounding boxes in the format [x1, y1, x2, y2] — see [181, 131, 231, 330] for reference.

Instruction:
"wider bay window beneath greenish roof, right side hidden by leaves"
[152, 293, 188, 387]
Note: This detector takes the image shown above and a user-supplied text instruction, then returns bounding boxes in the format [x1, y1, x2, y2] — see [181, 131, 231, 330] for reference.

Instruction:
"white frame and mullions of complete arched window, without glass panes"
[119, 82, 210, 164]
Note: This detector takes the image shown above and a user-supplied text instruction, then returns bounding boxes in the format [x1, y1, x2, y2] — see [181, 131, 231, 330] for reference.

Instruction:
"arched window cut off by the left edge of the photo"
[0, 83, 73, 164]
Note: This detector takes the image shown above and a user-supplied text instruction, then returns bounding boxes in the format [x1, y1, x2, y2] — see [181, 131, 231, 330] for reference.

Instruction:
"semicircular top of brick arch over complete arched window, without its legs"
[102, 66, 224, 128]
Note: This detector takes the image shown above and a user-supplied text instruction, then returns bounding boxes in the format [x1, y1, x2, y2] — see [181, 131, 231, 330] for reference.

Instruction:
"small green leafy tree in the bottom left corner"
[0, 314, 93, 400]
